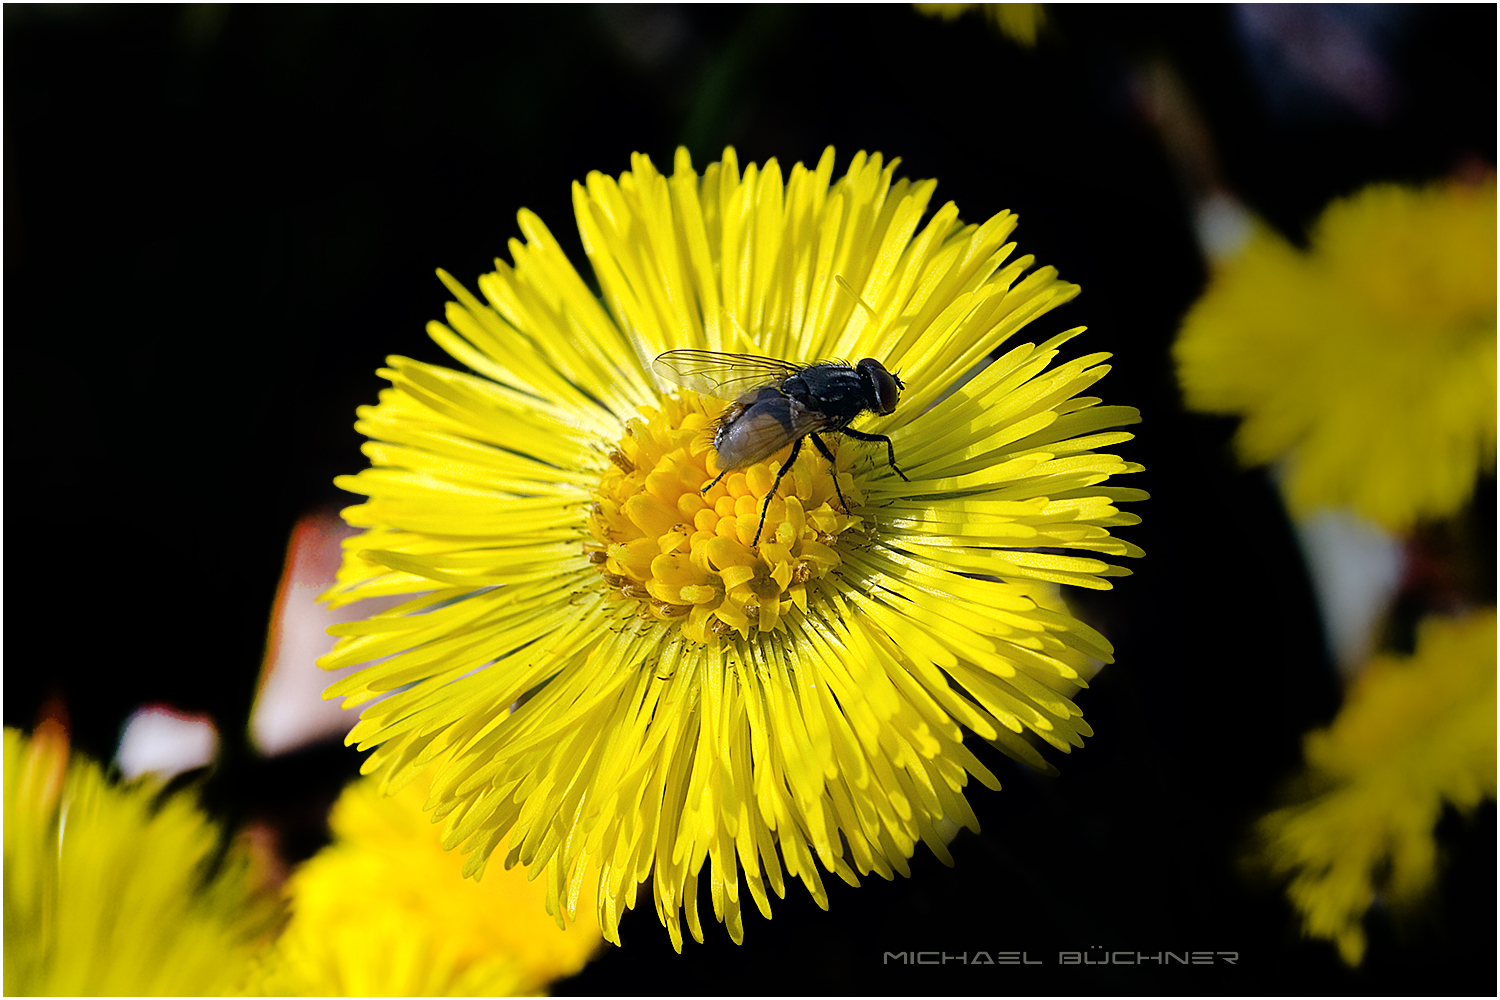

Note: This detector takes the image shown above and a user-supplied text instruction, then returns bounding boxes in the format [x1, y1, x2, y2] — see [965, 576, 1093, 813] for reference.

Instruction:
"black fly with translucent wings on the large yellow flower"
[651, 351, 911, 546]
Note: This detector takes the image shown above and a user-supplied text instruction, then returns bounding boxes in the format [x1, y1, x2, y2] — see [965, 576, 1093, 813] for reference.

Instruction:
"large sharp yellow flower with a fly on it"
[323, 150, 1143, 948]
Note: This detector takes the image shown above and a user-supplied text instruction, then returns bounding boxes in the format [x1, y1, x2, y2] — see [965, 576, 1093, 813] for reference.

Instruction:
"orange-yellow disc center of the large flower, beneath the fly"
[584, 393, 864, 642]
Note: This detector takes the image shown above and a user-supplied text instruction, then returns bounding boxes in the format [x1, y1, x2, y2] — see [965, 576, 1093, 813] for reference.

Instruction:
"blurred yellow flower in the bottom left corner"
[5, 723, 276, 997]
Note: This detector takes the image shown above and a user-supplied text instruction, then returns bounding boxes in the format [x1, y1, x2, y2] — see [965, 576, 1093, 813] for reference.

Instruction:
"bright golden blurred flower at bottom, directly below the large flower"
[254, 778, 602, 997]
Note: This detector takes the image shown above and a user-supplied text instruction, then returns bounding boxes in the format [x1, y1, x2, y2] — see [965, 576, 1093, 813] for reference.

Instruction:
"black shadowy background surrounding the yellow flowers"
[5, 4, 1496, 994]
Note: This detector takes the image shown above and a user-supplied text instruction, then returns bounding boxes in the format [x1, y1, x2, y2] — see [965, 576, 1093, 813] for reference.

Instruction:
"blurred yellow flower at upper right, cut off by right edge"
[1175, 177, 1496, 531]
